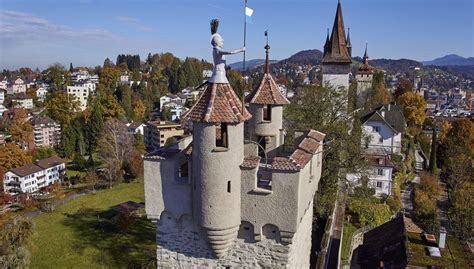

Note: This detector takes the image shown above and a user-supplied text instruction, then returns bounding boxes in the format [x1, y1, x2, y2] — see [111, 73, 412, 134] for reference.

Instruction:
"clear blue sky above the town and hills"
[0, 0, 474, 69]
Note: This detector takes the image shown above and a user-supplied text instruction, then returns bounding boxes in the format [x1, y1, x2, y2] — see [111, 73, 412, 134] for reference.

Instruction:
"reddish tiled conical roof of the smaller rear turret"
[246, 73, 290, 105]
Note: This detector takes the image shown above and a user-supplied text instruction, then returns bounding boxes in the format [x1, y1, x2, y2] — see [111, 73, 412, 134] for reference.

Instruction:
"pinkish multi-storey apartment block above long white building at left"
[30, 116, 61, 147]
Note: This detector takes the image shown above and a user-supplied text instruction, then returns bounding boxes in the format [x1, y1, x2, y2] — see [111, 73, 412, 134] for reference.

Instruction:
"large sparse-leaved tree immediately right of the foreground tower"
[284, 86, 366, 217]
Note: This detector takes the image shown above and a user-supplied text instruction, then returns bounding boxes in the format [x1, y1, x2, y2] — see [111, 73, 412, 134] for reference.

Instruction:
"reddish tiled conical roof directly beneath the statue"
[183, 83, 252, 123]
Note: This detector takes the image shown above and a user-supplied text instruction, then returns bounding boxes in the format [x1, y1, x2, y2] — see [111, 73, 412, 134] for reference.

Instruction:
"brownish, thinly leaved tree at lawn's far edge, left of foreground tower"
[98, 119, 134, 187]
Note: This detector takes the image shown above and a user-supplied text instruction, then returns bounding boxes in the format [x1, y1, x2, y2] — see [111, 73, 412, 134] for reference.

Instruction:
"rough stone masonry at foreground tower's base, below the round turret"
[156, 203, 313, 268]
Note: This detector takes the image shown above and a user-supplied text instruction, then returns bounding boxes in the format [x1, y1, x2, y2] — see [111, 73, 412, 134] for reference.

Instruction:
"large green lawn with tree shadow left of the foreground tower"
[30, 182, 156, 268]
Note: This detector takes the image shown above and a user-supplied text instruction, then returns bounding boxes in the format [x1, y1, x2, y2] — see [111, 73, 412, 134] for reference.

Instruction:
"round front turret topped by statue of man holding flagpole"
[184, 17, 251, 258]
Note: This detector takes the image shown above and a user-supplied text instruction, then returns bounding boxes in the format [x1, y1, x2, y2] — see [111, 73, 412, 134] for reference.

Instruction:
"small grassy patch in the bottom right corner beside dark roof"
[407, 233, 471, 268]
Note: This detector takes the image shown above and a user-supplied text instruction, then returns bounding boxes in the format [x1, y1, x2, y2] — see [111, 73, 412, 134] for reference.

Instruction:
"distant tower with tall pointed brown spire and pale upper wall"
[322, 0, 352, 91]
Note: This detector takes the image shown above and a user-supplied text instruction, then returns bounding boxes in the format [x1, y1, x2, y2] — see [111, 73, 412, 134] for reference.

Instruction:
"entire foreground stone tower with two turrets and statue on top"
[144, 19, 325, 268]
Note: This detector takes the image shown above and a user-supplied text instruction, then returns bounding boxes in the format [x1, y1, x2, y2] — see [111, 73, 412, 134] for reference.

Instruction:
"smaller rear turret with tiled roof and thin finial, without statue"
[246, 44, 290, 157]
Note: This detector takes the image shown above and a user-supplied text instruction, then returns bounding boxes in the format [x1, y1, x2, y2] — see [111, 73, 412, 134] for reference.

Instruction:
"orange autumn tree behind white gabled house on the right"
[398, 92, 426, 127]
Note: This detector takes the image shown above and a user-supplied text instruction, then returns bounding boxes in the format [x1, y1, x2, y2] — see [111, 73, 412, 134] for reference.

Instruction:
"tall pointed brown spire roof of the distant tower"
[323, 0, 352, 64]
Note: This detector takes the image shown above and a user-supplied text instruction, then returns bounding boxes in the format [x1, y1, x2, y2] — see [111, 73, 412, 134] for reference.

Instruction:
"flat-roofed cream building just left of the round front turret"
[144, 121, 184, 151]
